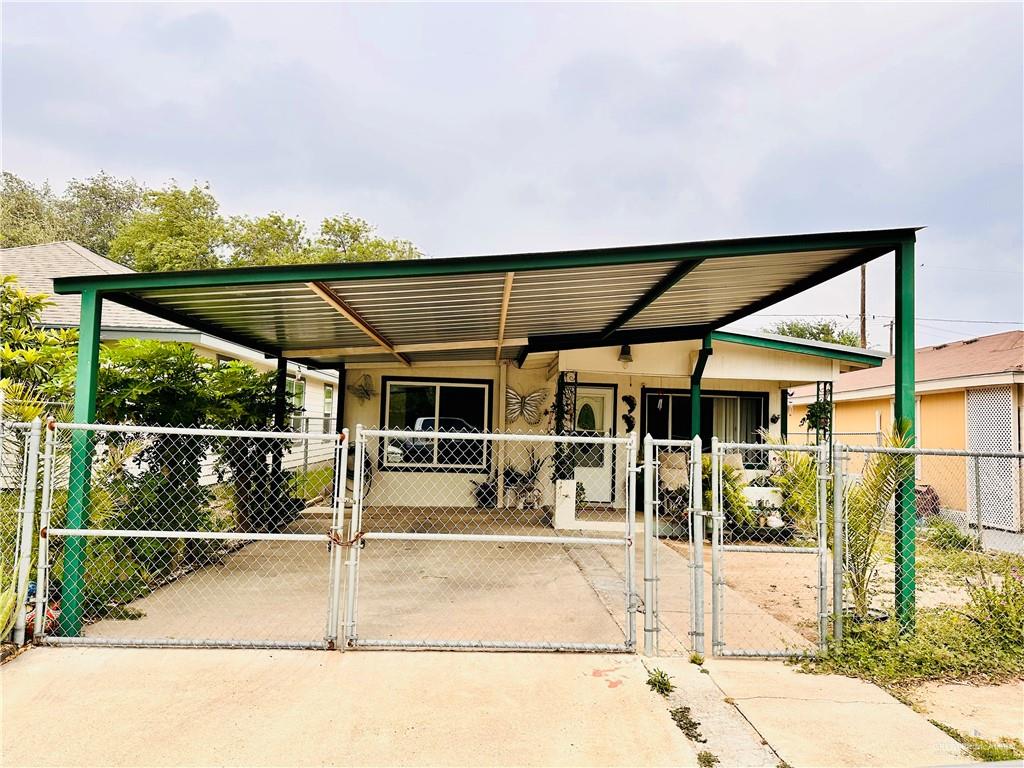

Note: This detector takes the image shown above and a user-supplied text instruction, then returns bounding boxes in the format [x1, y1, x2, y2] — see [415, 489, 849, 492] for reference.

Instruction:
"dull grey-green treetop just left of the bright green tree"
[55, 171, 145, 256]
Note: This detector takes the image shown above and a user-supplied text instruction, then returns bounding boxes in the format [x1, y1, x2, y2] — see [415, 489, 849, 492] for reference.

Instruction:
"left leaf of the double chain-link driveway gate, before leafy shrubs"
[33, 422, 348, 648]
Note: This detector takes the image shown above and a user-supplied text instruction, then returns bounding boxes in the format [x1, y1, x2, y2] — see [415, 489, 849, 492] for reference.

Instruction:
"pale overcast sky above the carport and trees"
[2, 2, 1024, 347]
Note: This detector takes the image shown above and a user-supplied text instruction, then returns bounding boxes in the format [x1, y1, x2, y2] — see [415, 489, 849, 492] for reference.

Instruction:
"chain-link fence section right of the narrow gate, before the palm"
[836, 445, 1024, 633]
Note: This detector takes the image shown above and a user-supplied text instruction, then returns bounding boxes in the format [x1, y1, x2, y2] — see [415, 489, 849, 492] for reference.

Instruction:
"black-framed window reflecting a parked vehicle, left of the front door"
[383, 380, 490, 469]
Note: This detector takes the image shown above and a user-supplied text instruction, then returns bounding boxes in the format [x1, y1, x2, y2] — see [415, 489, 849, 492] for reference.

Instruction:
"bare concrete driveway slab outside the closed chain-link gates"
[0, 648, 697, 766]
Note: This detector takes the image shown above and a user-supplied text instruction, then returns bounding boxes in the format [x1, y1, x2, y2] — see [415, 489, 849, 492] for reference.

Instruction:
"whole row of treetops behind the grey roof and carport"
[0, 171, 420, 271]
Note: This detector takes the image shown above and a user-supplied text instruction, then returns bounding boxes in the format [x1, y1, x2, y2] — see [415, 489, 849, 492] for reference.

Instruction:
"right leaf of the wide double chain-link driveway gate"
[344, 426, 637, 651]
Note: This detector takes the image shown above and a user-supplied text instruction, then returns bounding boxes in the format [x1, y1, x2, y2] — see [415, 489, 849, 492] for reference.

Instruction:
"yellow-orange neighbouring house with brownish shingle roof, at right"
[788, 331, 1024, 530]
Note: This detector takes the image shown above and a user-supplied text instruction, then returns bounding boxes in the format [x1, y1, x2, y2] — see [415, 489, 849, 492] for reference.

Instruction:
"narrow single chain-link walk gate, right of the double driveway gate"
[710, 438, 842, 657]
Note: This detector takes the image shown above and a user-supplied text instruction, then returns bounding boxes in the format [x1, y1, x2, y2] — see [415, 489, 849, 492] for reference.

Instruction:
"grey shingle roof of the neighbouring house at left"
[0, 241, 184, 331]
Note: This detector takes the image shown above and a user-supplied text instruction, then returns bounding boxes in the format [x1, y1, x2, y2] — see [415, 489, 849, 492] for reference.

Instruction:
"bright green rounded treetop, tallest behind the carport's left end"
[110, 183, 227, 271]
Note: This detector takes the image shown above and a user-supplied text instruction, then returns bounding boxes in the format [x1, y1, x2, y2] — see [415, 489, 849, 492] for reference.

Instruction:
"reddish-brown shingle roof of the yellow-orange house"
[794, 331, 1024, 396]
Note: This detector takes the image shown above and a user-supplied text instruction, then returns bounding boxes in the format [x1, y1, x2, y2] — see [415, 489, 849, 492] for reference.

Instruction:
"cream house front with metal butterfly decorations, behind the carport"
[343, 332, 885, 509]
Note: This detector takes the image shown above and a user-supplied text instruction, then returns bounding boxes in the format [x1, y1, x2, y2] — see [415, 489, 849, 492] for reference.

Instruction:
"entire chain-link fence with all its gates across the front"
[0, 422, 1024, 655]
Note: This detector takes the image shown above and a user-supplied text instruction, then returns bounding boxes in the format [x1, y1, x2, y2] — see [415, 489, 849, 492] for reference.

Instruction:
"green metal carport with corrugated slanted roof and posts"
[54, 227, 918, 636]
